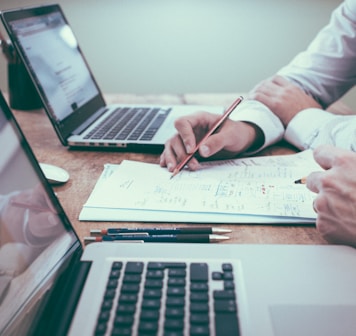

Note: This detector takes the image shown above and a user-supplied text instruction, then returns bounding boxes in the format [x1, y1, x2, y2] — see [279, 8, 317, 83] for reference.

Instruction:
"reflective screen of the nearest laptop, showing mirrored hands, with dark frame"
[0, 94, 78, 335]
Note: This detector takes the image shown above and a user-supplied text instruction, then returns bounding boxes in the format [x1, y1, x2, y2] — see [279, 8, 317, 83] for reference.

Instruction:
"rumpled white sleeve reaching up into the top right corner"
[278, 0, 356, 108]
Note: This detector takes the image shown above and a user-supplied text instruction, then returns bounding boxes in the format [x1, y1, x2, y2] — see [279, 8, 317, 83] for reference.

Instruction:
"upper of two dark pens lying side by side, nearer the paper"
[90, 227, 231, 236]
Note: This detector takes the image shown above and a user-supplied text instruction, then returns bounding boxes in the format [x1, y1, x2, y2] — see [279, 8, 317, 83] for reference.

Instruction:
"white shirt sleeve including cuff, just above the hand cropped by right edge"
[284, 108, 356, 152]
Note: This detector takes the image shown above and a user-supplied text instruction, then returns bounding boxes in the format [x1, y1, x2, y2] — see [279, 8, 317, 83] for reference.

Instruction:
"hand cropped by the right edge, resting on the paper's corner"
[307, 145, 356, 247]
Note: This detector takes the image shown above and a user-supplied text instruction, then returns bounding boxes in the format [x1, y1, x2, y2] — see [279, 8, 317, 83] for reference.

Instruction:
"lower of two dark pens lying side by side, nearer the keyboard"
[84, 234, 230, 243]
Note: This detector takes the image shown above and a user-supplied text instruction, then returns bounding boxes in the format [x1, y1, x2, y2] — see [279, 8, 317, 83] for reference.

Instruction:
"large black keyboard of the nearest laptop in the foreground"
[95, 261, 239, 336]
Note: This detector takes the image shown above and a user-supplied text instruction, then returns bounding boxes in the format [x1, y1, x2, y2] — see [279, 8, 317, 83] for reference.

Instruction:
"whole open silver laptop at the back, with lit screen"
[1, 4, 223, 152]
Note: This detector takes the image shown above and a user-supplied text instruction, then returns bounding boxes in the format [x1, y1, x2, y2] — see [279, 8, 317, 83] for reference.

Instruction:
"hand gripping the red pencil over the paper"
[160, 112, 263, 171]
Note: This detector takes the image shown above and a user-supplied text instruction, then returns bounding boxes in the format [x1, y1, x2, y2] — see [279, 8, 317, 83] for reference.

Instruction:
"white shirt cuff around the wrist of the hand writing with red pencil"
[230, 100, 284, 154]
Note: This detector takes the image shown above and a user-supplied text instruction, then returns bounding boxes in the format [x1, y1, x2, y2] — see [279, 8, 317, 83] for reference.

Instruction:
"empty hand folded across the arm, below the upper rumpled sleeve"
[248, 75, 321, 127]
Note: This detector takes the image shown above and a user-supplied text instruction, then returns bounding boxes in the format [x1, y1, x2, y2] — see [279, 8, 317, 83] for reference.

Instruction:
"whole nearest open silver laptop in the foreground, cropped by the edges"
[0, 89, 356, 336]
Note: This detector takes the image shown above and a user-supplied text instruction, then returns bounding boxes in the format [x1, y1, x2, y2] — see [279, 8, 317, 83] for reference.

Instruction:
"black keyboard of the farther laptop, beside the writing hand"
[84, 107, 172, 141]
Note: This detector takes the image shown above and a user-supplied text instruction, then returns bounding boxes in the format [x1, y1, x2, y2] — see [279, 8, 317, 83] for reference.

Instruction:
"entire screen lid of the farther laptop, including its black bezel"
[1, 4, 106, 146]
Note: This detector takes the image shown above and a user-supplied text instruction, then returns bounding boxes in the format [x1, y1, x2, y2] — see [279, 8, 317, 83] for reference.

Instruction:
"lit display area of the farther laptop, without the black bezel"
[6, 11, 98, 121]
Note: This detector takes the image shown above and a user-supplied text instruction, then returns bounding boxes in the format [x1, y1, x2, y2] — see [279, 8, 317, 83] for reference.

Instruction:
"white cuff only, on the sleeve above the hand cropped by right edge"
[284, 108, 335, 150]
